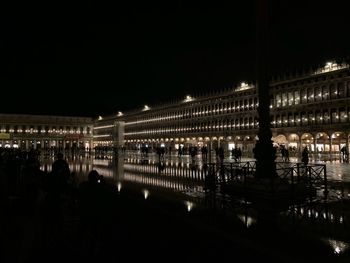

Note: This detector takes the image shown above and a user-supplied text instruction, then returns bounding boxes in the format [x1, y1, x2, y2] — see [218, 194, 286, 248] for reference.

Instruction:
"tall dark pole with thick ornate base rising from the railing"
[254, 0, 276, 178]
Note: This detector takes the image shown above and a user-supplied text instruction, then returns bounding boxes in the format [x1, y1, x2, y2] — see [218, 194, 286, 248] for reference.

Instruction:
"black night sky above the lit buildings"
[0, 0, 350, 117]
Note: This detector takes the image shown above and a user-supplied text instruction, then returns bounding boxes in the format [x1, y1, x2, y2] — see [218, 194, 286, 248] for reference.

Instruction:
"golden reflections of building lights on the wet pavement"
[41, 156, 350, 262]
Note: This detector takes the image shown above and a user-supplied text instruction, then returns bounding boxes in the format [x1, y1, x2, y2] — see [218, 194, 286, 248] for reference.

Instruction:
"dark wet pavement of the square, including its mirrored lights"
[1, 153, 350, 262]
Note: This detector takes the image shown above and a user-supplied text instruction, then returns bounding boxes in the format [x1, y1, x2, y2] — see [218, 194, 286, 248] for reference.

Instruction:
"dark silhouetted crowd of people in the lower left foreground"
[0, 148, 117, 261]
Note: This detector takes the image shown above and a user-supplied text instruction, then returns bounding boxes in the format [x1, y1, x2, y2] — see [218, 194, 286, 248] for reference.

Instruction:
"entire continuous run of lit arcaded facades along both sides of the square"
[0, 62, 350, 156]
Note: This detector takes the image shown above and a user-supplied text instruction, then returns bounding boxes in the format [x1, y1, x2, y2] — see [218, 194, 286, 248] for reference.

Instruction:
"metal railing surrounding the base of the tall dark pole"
[205, 162, 328, 198]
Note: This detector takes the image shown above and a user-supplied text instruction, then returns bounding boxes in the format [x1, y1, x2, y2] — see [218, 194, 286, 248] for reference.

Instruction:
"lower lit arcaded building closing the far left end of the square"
[0, 114, 92, 149]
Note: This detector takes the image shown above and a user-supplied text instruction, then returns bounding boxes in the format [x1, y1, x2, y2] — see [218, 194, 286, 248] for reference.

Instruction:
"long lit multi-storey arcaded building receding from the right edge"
[94, 62, 350, 156]
